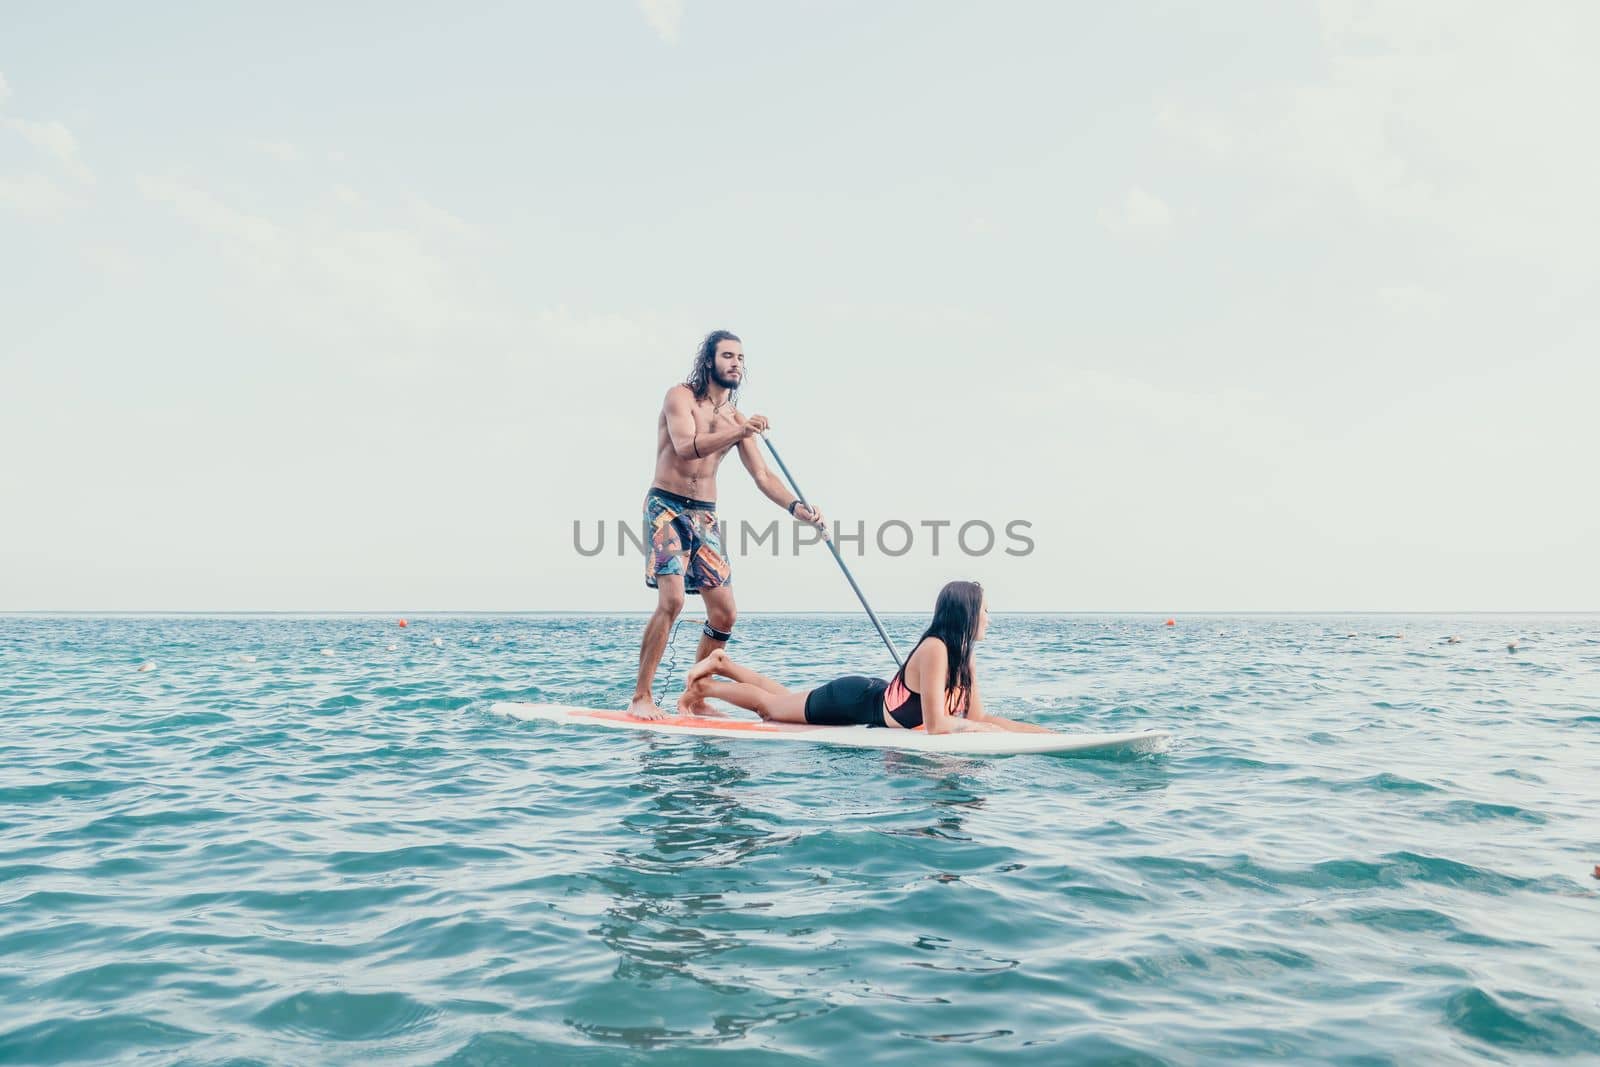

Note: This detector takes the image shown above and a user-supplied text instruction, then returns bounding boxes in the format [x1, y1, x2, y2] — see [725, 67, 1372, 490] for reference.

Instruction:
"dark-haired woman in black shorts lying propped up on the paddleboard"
[678, 582, 1051, 734]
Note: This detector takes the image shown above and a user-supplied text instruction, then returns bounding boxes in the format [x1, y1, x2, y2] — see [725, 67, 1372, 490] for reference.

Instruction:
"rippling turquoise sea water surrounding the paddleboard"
[0, 614, 1600, 1064]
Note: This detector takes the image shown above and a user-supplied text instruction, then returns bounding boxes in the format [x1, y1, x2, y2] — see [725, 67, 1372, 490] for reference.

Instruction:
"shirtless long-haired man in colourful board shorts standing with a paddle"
[627, 330, 822, 718]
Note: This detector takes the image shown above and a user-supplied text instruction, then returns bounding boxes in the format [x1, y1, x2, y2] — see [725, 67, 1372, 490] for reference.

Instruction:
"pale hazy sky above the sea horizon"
[0, 0, 1600, 613]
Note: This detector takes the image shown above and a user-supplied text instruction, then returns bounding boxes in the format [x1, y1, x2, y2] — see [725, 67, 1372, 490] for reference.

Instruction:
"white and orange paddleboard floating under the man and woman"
[490, 702, 1173, 755]
